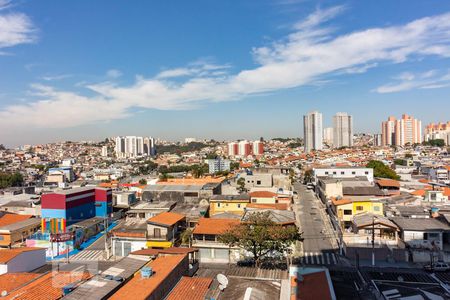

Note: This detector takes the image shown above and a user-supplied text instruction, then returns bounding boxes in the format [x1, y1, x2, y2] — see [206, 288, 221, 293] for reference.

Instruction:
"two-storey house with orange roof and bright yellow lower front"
[147, 212, 186, 248]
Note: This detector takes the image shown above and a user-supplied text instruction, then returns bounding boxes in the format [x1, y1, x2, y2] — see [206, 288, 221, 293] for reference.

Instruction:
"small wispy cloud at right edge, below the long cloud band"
[375, 70, 450, 94]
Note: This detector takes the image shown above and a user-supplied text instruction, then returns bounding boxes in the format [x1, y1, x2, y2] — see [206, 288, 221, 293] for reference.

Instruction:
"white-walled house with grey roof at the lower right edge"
[391, 217, 450, 250]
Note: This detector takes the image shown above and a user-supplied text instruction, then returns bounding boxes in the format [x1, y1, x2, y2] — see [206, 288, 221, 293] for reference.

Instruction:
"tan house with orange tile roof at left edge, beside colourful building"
[0, 214, 41, 247]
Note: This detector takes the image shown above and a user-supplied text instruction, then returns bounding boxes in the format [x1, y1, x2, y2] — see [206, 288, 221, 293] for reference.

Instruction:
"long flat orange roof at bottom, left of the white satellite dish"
[109, 255, 186, 300]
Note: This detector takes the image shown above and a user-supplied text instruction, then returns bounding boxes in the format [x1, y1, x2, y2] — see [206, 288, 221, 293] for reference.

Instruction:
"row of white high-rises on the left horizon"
[115, 136, 156, 158]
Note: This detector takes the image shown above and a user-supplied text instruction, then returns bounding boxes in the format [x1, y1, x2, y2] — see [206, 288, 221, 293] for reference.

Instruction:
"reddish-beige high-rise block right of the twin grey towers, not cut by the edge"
[381, 114, 422, 146]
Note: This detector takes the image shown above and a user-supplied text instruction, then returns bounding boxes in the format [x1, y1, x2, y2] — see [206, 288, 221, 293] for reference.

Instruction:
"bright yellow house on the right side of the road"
[331, 198, 384, 229]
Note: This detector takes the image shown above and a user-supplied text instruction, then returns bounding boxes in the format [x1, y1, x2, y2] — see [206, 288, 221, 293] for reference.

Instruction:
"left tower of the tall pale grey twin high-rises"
[303, 111, 323, 152]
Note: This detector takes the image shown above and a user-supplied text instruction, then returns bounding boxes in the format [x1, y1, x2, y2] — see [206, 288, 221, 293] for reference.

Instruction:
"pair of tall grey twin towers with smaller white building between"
[303, 111, 353, 152]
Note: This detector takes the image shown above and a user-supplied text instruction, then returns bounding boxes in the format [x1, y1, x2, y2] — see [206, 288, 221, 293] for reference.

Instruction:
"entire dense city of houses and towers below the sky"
[0, 116, 450, 299]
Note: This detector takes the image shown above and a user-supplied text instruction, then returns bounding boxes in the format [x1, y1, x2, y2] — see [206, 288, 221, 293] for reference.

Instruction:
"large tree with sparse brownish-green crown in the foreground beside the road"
[219, 212, 302, 265]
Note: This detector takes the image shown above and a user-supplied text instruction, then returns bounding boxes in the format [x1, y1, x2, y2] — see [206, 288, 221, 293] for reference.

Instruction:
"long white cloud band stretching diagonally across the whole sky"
[0, 6, 450, 127]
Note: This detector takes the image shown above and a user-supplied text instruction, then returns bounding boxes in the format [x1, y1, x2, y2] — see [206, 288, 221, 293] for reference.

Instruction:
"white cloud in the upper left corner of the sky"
[0, 12, 36, 48]
